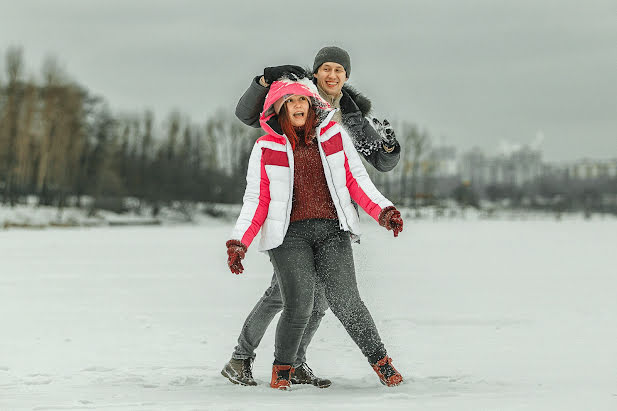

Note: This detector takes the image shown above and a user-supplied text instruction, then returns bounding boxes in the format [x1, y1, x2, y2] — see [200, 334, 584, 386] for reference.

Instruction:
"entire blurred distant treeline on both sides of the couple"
[0, 47, 617, 217]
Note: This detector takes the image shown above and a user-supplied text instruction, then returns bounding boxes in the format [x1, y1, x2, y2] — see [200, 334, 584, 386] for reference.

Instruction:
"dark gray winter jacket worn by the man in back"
[236, 76, 401, 171]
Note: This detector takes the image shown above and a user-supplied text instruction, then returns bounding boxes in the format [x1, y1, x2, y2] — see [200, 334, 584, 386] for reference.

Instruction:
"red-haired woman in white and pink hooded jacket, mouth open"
[227, 79, 403, 389]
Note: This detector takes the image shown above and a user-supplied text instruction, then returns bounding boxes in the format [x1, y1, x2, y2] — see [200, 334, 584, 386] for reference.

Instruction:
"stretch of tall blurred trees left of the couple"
[0, 47, 261, 214]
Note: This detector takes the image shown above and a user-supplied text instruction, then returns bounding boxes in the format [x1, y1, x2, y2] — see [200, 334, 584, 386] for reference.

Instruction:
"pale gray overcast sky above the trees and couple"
[0, 0, 617, 161]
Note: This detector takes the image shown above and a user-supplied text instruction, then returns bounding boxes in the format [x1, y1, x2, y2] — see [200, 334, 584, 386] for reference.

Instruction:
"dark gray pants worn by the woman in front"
[269, 219, 386, 364]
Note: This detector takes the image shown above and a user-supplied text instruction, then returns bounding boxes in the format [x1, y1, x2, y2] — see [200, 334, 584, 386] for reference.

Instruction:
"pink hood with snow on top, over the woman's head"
[259, 78, 332, 135]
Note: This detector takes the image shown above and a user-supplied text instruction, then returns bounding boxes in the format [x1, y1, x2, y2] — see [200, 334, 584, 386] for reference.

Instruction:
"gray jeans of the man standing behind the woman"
[232, 274, 328, 366]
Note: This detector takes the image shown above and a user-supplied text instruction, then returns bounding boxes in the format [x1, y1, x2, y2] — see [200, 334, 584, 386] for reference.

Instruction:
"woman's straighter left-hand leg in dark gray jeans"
[269, 224, 316, 365]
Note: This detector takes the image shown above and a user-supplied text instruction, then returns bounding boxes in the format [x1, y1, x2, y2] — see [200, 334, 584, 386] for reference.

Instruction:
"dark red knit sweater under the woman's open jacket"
[290, 138, 338, 222]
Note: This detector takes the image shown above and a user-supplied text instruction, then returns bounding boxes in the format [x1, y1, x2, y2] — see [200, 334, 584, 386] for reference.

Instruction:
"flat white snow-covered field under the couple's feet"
[0, 219, 617, 411]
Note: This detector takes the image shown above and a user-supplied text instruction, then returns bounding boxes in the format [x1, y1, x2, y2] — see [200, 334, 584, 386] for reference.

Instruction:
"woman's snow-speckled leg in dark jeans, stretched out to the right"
[315, 224, 387, 364]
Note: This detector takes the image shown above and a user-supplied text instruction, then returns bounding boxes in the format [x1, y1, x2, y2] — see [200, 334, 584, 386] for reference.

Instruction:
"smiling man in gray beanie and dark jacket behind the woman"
[221, 46, 401, 388]
